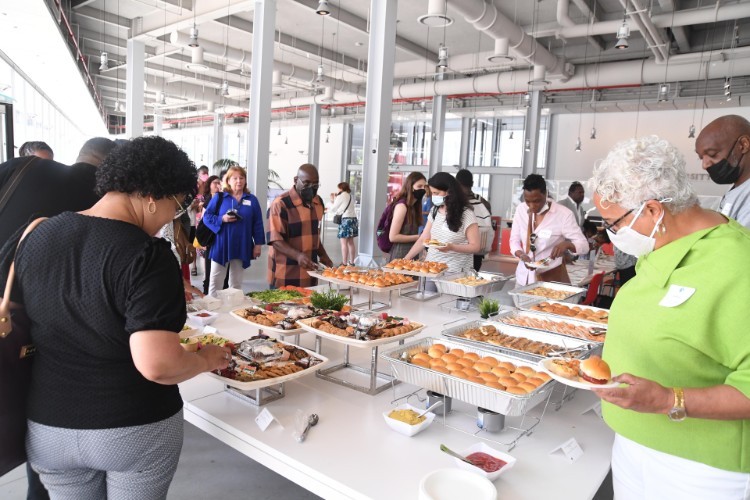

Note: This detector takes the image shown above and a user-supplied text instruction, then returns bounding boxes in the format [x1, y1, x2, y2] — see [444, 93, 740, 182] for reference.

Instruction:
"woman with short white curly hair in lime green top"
[590, 136, 750, 500]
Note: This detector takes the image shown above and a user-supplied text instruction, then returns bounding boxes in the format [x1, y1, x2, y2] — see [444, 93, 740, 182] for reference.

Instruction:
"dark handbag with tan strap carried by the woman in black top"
[0, 218, 46, 476]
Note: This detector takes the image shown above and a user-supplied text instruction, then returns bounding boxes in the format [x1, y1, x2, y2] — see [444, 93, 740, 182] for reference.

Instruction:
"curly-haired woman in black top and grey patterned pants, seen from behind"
[0, 137, 230, 500]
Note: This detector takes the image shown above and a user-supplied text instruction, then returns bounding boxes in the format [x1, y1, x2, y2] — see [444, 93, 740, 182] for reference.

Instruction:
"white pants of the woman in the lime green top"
[612, 434, 750, 500]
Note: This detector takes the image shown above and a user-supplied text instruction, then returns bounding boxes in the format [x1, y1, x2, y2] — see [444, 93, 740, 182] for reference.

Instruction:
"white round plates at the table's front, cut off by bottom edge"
[418, 469, 497, 500]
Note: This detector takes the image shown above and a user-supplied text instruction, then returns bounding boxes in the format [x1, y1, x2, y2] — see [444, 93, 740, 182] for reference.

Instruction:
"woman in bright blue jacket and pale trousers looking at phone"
[203, 167, 266, 295]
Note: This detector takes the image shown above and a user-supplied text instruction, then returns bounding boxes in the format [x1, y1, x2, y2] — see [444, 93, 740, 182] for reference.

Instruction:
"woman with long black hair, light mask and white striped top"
[405, 172, 480, 271]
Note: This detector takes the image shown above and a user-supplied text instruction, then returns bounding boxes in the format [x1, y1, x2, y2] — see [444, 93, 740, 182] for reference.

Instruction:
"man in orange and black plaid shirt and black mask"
[268, 163, 333, 288]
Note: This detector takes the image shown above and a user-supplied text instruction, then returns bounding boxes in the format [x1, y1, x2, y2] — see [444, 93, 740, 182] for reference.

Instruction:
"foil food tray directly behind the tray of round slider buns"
[442, 320, 601, 362]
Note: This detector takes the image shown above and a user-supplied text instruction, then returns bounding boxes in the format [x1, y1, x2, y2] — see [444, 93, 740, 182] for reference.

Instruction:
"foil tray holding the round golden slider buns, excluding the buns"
[380, 338, 554, 416]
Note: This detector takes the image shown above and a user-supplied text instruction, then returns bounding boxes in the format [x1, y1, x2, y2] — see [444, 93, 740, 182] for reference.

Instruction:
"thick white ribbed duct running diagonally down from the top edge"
[448, 0, 572, 80]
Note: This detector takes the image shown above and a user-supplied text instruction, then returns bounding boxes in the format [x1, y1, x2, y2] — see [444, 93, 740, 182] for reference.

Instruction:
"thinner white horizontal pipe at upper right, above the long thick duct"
[552, 2, 750, 38]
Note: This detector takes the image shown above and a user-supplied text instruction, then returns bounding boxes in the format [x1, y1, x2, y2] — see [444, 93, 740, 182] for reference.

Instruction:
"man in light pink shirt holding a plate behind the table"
[510, 174, 589, 286]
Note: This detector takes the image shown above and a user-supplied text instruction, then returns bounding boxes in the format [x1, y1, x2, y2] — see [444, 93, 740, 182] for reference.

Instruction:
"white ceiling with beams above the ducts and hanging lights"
[0, 0, 750, 132]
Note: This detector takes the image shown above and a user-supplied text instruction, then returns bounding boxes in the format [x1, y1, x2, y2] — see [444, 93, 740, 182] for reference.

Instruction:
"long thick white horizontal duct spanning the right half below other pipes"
[393, 51, 750, 99]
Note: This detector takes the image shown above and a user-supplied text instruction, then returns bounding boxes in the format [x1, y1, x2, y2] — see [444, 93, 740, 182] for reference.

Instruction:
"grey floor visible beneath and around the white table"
[0, 227, 612, 500]
